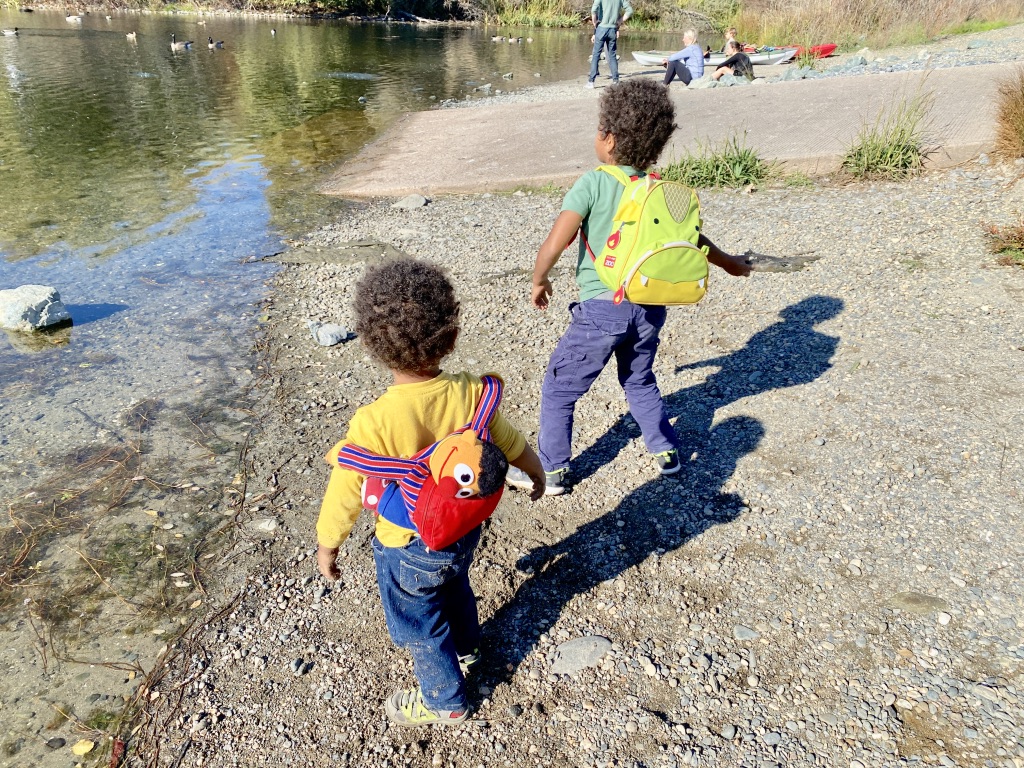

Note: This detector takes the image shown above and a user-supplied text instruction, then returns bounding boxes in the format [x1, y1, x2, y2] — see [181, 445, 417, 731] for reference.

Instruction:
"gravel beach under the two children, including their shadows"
[119, 148, 1024, 768]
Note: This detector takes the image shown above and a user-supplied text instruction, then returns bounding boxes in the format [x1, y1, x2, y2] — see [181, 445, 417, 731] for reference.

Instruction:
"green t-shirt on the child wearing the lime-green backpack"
[562, 165, 639, 301]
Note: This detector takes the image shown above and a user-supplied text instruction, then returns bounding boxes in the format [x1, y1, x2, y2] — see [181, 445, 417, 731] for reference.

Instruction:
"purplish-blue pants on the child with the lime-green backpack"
[538, 299, 677, 472]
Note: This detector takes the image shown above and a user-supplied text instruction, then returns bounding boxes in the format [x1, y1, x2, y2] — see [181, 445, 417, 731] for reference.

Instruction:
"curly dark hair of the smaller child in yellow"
[353, 257, 459, 372]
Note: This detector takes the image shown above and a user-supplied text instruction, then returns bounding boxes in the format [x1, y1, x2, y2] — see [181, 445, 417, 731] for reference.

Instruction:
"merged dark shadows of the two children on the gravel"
[483, 296, 843, 684]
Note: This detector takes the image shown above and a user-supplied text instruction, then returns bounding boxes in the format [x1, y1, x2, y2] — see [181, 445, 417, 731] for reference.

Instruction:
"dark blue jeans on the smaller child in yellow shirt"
[373, 528, 480, 711]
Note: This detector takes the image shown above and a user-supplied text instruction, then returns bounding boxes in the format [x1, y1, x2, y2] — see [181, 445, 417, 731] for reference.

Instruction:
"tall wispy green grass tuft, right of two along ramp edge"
[843, 91, 932, 179]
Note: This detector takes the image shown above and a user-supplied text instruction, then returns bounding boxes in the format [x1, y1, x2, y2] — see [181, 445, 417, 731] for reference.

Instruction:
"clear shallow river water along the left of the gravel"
[0, 8, 679, 765]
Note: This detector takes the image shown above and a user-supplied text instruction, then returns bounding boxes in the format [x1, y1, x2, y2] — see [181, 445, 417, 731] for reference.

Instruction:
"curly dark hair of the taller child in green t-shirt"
[598, 80, 679, 171]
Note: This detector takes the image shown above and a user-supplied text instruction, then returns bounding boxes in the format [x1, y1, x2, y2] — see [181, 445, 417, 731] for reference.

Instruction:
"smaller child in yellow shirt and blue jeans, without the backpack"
[316, 258, 544, 725]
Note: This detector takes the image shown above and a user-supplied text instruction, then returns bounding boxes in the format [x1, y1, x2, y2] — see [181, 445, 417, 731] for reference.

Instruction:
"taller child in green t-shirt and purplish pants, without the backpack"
[509, 80, 751, 496]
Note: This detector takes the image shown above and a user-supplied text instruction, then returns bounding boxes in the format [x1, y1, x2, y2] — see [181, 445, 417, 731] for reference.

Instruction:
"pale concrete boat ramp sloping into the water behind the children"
[323, 65, 1008, 198]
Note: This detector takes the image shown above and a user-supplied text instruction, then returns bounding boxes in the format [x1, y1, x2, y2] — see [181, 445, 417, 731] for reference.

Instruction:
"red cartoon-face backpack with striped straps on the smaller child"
[338, 374, 508, 550]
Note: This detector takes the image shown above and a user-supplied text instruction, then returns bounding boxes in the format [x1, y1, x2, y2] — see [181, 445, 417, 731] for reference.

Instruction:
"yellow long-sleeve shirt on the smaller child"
[316, 372, 526, 548]
